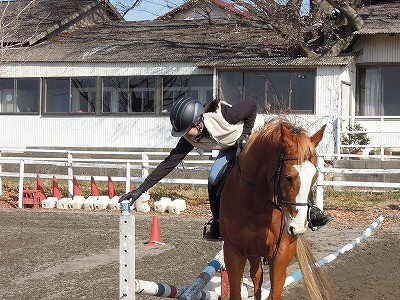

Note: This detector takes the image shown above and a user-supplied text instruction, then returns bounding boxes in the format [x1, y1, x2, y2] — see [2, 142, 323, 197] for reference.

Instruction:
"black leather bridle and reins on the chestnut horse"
[236, 148, 311, 264]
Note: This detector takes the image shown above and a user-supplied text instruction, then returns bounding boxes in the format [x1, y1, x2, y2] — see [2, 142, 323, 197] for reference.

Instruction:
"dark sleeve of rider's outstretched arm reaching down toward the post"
[140, 137, 194, 191]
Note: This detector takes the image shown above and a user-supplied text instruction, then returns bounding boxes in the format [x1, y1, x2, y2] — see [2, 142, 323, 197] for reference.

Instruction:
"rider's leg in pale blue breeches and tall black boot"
[203, 148, 236, 240]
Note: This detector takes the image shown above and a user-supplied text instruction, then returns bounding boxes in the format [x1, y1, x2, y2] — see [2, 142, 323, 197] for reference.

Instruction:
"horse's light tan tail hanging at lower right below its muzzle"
[296, 237, 334, 300]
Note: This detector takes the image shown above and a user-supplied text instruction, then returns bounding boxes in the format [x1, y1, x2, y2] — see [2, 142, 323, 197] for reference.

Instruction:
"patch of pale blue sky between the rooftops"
[111, 0, 184, 21]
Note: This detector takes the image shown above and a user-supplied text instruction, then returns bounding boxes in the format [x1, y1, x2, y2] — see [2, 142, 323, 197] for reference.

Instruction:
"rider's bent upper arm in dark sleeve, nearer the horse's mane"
[221, 100, 257, 135]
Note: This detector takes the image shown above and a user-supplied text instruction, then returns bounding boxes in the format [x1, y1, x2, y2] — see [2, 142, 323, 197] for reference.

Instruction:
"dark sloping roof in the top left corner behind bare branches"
[0, 0, 122, 45]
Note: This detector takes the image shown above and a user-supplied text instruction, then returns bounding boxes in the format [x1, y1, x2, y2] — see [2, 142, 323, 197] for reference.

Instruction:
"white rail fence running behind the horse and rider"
[0, 149, 400, 209]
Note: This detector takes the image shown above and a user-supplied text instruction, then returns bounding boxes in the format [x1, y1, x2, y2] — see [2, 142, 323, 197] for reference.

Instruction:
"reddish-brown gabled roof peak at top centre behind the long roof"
[156, 0, 250, 20]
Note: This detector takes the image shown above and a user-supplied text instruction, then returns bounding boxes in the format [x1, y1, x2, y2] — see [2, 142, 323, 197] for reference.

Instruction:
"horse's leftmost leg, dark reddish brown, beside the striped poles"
[224, 241, 246, 300]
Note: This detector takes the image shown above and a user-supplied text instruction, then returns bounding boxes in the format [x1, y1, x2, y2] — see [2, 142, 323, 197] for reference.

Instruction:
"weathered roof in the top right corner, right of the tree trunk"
[355, 0, 400, 34]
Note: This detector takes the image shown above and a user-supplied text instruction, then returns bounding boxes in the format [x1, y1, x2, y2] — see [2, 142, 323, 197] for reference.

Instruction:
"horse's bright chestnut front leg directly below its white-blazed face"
[268, 239, 296, 300]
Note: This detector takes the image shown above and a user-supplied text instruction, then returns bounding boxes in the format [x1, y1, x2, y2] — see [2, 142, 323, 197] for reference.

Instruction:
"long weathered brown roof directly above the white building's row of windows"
[10, 20, 295, 62]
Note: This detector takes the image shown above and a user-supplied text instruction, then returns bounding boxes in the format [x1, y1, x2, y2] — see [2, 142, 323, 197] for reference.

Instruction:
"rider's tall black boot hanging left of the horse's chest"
[203, 185, 221, 241]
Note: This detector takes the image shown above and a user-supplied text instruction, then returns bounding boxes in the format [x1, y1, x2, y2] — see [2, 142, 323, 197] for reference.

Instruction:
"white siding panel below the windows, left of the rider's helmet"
[0, 115, 177, 148]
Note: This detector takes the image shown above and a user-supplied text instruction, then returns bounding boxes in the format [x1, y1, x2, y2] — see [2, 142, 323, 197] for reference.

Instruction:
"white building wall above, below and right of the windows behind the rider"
[0, 63, 350, 152]
